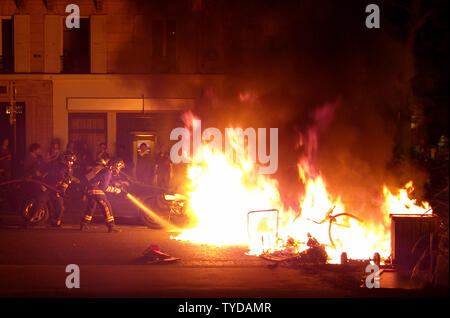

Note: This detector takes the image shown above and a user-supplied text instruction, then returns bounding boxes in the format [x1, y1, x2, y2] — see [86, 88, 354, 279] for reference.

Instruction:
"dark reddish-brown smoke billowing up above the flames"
[117, 0, 432, 216]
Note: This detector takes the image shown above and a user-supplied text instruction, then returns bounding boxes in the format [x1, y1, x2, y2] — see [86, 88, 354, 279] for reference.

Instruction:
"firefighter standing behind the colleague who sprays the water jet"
[39, 152, 77, 227]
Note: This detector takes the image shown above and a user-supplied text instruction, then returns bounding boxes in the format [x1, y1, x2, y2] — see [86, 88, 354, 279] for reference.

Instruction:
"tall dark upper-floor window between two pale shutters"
[62, 18, 91, 74]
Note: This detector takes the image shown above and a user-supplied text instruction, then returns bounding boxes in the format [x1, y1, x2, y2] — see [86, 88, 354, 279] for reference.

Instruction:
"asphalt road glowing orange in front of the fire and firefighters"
[0, 217, 448, 297]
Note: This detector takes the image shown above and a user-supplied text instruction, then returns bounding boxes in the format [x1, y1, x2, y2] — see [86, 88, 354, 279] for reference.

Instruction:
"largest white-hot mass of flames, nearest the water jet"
[177, 147, 282, 246]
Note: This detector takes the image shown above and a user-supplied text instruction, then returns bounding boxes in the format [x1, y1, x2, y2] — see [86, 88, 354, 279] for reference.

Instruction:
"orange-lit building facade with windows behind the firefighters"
[0, 0, 224, 169]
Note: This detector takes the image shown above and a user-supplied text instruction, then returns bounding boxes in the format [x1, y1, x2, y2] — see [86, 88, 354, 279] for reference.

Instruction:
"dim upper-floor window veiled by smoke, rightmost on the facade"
[152, 20, 177, 73]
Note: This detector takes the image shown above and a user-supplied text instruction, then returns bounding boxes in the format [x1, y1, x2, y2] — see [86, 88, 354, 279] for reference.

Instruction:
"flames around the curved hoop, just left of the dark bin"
[289, 166, 390, 263]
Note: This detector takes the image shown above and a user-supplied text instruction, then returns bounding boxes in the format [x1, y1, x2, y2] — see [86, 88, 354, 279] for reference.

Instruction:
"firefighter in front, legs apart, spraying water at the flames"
[80, 159, 125, 233]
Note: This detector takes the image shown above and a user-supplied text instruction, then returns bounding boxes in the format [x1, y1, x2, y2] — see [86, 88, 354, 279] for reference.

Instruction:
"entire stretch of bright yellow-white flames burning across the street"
[174, 114, 432, 263]
